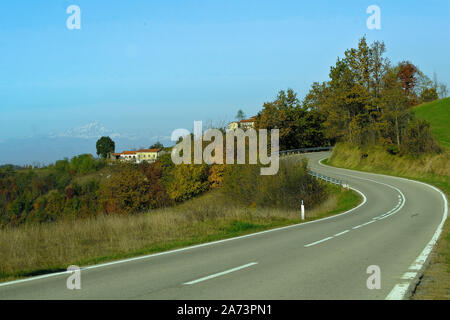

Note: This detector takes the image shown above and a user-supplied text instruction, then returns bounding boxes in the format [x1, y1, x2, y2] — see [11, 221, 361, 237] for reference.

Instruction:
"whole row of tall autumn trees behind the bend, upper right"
[256, 37, 448, 155]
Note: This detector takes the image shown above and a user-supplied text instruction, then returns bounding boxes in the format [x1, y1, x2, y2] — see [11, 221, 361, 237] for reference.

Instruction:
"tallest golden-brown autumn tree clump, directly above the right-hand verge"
[304, 37, 438, 153]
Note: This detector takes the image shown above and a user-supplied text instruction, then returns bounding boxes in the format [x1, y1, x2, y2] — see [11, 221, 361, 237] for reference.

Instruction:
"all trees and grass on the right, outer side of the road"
[298, 38, 450, 299]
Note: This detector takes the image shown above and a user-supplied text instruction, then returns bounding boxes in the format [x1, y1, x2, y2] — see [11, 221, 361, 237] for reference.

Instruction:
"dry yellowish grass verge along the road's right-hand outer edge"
[326, 145, 450, 299]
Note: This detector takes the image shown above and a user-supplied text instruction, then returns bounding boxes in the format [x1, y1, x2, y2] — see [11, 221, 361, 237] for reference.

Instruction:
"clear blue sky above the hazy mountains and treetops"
[0, 0, 450, 162]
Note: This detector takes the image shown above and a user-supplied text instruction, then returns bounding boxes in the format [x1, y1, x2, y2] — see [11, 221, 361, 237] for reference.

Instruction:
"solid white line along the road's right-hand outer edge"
[319, 154, 448, 300]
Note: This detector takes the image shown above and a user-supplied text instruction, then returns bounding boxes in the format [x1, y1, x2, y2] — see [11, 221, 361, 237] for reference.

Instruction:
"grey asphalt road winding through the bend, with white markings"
[0, 152, 447, 299]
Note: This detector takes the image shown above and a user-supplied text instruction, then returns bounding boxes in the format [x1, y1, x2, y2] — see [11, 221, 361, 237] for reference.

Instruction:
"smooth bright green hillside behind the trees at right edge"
[414, 98, 450, 149]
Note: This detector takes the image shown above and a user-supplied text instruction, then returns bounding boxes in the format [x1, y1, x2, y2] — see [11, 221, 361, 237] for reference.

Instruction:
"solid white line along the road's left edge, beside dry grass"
[0, 171, 367, 287]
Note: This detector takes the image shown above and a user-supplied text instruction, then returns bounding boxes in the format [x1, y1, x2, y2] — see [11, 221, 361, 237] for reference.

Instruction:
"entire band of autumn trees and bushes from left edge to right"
[0, 38, 447, 227]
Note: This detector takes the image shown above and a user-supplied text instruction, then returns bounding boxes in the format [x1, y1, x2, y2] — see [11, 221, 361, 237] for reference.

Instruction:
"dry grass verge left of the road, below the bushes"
[0, 185, 361, 281]
